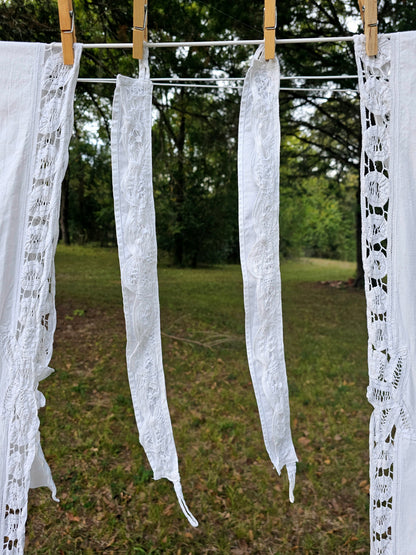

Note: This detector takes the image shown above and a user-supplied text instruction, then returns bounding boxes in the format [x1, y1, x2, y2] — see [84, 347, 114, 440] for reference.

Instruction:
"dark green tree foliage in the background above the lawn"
[0, 0, 416, 265]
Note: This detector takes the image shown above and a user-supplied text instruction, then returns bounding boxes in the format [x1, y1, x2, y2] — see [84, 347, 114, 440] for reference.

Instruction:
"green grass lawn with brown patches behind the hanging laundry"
[26, 247, 370, 555]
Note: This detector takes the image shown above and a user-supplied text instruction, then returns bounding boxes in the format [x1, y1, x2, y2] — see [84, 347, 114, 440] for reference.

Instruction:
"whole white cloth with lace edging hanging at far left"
[0, 42, 81, 554]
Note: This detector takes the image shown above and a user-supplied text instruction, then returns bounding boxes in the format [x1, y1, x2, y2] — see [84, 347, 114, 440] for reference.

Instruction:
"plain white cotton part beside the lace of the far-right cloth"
[391, 32, 416, 555]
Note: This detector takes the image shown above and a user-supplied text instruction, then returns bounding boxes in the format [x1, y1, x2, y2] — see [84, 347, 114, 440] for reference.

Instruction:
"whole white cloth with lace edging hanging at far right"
[354, 32, 416, 555]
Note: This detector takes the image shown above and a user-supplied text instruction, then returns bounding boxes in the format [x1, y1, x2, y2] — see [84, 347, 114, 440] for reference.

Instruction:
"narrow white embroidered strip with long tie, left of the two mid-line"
[111, 49, 198, 526]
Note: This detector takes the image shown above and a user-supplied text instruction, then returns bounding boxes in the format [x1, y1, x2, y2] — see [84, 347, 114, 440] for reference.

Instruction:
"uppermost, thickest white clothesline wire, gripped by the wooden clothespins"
[83, 35, 354, 49]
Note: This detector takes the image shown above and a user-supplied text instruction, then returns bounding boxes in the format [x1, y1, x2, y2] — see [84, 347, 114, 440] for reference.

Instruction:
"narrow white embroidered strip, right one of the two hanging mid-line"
[238, 46, 297, 502]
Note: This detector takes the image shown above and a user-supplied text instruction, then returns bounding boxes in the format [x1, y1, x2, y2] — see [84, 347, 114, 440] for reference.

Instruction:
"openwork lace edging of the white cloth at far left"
[0, 44, 81, 555]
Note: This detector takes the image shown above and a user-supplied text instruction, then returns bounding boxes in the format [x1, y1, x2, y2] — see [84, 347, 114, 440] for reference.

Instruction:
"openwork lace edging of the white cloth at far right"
[354, 35, 410, 555]
